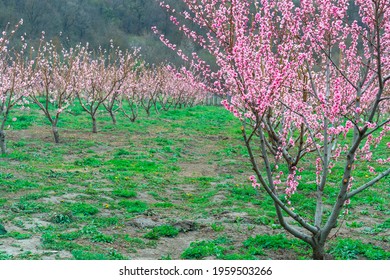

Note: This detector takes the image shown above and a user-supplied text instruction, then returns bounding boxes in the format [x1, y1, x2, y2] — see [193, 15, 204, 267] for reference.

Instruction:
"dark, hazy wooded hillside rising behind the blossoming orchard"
[0, 0, 195, 63]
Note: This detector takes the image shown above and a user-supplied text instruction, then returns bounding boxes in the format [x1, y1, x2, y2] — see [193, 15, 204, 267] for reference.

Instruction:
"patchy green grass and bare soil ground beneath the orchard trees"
[0, 103, 390, 260]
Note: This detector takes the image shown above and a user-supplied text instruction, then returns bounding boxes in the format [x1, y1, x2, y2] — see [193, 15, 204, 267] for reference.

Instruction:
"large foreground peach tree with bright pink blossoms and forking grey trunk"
[154, 0, 390, 259]
